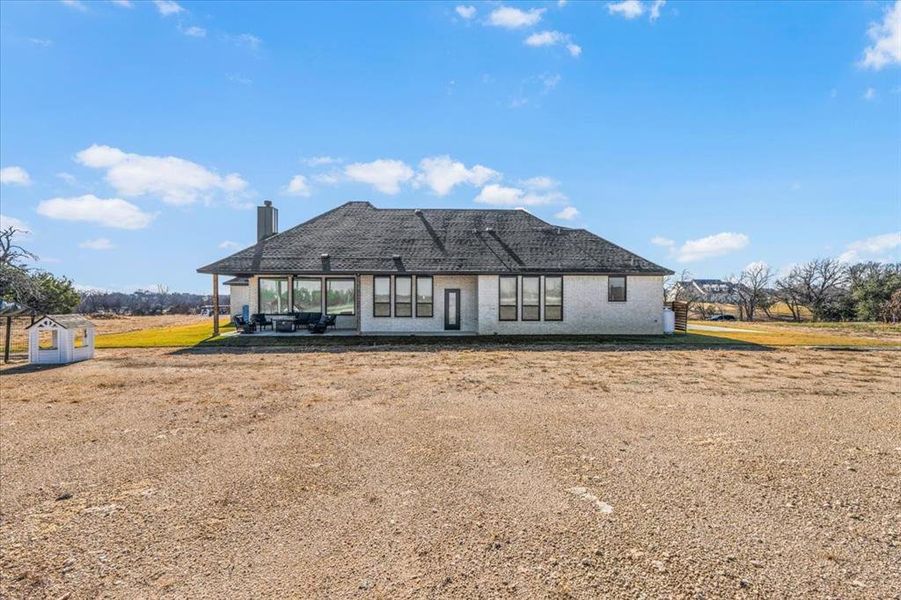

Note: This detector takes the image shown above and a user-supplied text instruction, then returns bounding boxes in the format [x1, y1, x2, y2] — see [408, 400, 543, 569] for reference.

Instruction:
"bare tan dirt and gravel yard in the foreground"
[0, 347, 901, 598]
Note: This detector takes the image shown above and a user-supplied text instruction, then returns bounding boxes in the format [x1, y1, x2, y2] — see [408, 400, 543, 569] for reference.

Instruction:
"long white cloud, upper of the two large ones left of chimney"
[75, 144, 247, 204]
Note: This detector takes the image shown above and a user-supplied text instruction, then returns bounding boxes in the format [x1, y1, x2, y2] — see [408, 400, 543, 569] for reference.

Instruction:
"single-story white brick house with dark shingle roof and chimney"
[198, 201, 672, 335]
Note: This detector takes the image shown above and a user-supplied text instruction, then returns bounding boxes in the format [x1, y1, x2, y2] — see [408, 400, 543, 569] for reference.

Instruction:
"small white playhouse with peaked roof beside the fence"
[28, 315, 94, 365]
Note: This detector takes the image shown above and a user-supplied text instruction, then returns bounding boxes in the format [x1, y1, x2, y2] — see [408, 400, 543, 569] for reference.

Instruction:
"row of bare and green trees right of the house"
[670, 258, 901, 323]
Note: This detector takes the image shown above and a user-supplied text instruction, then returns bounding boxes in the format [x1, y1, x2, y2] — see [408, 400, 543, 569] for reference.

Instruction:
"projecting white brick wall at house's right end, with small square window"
[478, 275, 663, 335]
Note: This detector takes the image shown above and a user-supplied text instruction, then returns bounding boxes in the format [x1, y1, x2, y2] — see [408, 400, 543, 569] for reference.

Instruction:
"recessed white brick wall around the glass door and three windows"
[360, 275, 479, 333]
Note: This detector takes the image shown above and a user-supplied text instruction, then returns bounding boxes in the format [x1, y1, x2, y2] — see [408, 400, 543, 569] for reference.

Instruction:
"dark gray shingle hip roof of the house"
[197, 202, 672, 276]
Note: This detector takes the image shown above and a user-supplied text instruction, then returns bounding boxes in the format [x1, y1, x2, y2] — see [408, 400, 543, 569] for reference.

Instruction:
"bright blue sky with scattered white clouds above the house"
[0, 0, 901, 291]
